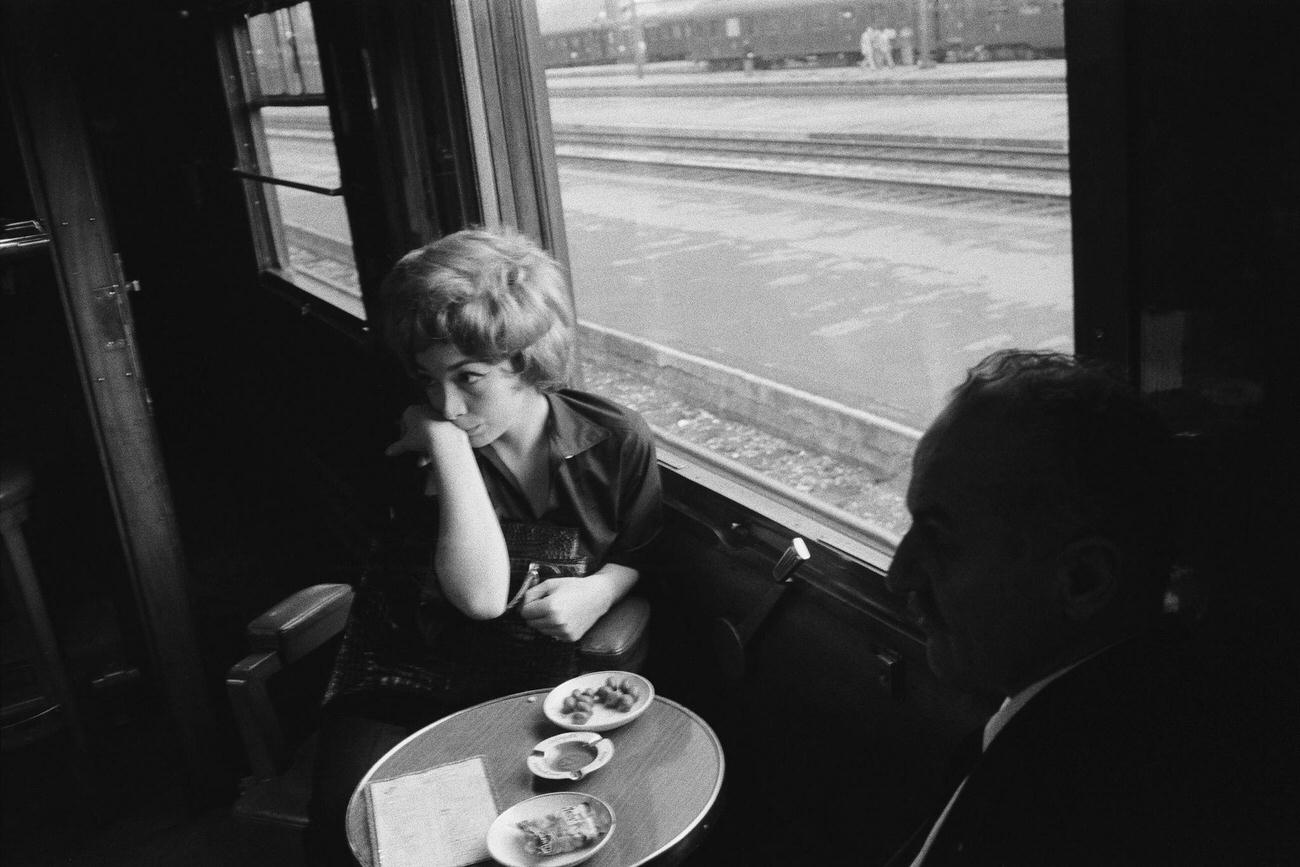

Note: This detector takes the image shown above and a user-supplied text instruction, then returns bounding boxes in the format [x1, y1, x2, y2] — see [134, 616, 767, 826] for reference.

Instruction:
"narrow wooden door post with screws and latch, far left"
[3, 3, 216, 789]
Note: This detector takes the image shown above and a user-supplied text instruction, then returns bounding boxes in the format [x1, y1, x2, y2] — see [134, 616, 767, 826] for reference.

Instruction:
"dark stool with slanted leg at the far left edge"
[0, 460, 86, 751]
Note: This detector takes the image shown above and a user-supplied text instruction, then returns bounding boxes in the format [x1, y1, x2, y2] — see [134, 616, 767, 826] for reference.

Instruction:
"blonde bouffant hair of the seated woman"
[380, 226, 575, 391]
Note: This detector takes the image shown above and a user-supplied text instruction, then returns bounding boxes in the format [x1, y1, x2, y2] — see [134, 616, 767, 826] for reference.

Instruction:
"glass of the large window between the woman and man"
[525, 0, 1074, 550]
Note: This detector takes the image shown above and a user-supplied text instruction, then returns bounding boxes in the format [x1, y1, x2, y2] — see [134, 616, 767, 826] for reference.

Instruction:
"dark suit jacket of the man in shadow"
[889, 633, 1251, 867]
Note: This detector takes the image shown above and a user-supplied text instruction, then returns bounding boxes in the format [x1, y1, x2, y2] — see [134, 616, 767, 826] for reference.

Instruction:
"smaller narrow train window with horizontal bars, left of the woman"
[222, 3, 365, 320]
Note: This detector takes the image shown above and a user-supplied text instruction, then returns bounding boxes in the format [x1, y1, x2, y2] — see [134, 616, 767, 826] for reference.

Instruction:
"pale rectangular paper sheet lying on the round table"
[369, 755, 497, 867]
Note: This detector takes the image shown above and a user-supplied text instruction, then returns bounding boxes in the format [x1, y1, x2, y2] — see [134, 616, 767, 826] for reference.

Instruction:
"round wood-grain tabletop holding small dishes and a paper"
[347, 690, 724, 867]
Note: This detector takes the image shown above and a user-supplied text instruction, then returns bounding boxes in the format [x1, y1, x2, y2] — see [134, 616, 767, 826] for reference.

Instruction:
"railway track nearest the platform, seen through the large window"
[554, 125, 1070, 201]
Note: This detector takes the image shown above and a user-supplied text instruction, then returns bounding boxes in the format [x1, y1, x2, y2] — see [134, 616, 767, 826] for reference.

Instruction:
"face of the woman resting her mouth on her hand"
[415, 342, 542, 448]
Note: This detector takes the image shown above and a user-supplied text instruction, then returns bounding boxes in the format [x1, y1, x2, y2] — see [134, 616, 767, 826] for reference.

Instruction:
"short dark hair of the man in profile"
[949, 350, 1178, 610]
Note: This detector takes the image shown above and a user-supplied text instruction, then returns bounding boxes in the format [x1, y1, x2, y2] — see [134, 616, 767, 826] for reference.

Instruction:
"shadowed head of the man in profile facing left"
[889, 351, 1173, 694]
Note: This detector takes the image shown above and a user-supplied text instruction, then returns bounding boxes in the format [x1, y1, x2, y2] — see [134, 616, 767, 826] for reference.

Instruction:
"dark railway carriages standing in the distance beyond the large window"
[538, 0, 1065, 70]
